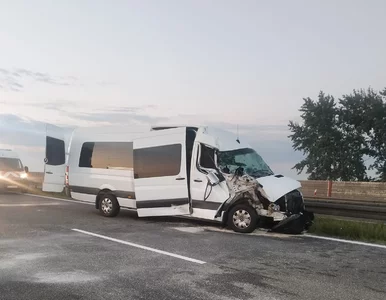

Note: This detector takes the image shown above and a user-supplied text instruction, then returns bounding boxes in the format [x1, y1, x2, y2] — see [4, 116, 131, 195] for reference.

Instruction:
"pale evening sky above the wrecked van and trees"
[0, 0, 386, 179]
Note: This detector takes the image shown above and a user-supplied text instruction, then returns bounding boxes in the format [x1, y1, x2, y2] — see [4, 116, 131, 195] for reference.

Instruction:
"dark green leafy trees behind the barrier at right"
[288, 88, 386, 181]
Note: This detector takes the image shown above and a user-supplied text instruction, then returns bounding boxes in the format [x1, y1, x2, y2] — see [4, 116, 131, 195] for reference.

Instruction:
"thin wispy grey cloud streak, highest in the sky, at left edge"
[0, 68, 78, 92]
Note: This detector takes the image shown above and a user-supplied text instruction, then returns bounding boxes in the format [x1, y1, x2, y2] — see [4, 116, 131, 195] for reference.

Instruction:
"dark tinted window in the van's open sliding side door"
[134, 144, 182, 178]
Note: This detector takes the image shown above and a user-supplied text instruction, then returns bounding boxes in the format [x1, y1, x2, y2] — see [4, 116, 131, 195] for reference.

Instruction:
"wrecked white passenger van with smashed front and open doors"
[43, 126, 312, 232]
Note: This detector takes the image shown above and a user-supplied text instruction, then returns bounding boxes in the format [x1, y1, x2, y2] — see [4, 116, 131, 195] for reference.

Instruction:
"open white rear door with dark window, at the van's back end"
[43, 124, 66, 193]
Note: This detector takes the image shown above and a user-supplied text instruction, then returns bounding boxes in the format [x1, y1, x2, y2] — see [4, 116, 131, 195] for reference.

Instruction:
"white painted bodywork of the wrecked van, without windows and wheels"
[43, 126, 301, 221]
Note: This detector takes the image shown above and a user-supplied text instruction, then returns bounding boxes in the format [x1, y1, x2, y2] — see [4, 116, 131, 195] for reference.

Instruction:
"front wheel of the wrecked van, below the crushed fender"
[228, 204, 259, 233]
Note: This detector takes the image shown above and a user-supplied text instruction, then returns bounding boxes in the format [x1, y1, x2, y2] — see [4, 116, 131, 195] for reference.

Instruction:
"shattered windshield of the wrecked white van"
[218, 148, 273, 178]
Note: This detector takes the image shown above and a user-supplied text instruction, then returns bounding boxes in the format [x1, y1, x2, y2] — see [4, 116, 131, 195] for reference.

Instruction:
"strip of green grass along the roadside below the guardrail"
[308, 216, 386, 244]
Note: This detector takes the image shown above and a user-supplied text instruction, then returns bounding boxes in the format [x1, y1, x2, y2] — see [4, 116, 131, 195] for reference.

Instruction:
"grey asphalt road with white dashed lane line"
[0, 194, 386, 300]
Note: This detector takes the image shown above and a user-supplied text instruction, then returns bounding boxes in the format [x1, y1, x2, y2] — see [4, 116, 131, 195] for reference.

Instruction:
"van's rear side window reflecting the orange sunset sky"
[79, 142, 133, 169]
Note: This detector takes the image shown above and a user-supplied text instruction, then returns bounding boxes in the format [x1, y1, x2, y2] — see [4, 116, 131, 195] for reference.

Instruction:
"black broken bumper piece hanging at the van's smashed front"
[269, 211, 314, 234]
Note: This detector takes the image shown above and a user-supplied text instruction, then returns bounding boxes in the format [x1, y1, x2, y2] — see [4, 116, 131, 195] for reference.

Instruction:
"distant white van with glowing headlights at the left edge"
[0, 149, 28, 192]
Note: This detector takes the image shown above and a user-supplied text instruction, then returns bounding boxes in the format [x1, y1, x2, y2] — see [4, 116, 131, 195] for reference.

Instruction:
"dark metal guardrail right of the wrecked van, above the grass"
[304, 198, 386, 221]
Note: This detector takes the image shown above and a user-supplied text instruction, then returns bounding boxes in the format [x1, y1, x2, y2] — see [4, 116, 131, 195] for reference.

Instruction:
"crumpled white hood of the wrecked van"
[257, 175, 302, 202]
